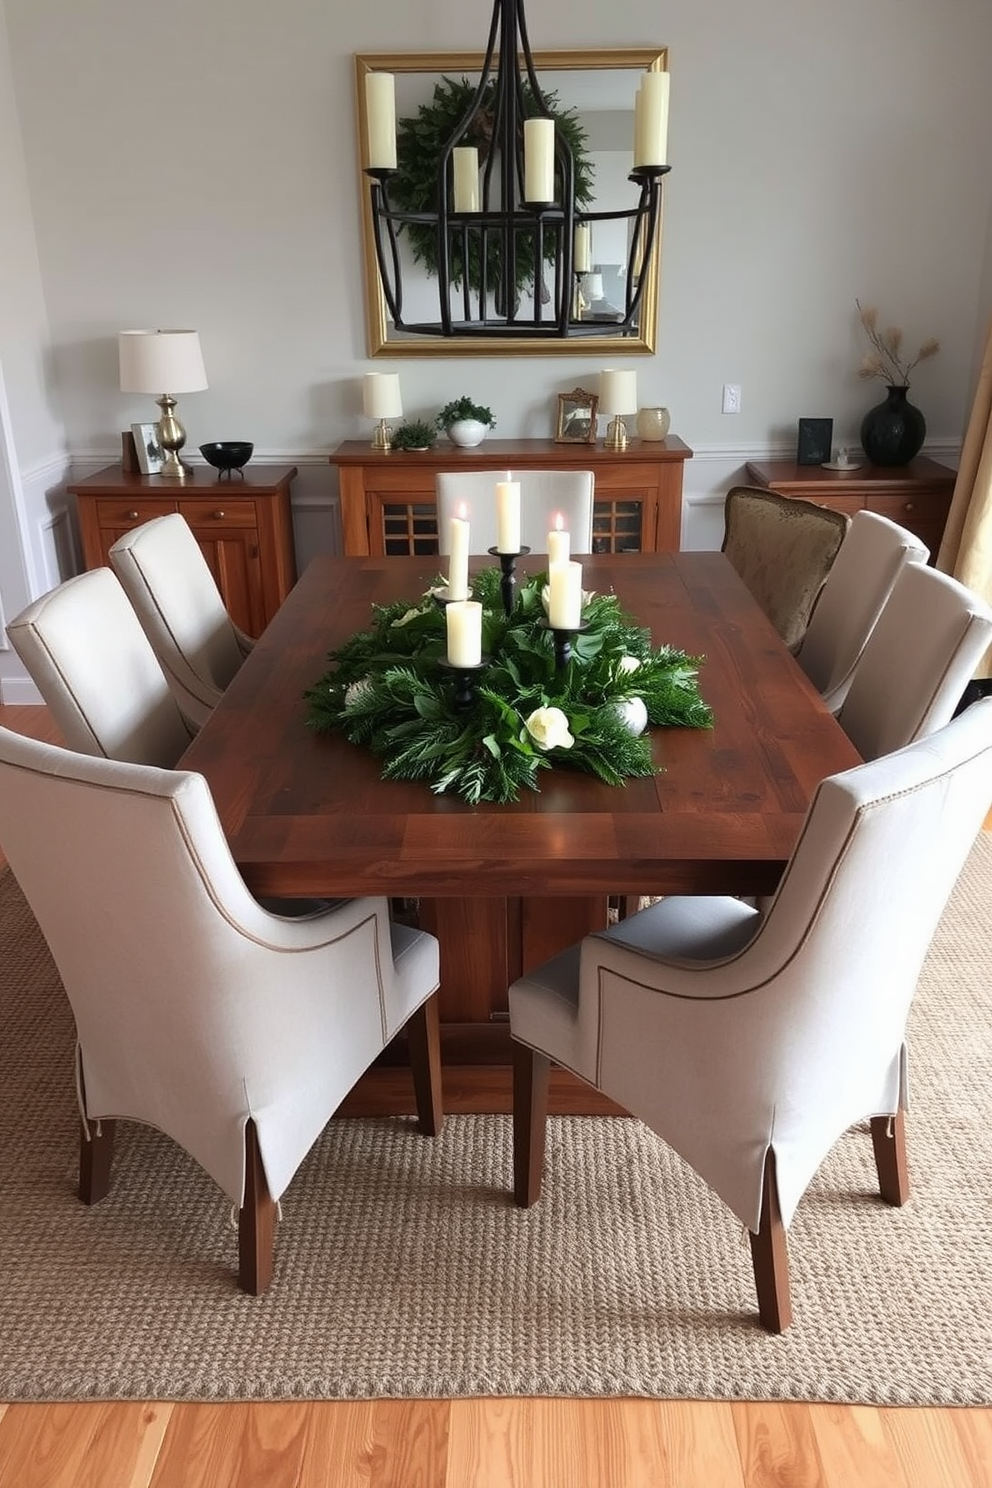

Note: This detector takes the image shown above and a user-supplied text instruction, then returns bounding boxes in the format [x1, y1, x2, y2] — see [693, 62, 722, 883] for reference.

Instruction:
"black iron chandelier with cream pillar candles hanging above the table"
[364, 0, 671, 339]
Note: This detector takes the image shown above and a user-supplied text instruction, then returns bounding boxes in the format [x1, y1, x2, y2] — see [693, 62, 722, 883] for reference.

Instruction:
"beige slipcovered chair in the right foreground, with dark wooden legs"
[510, 698, 992, 1332]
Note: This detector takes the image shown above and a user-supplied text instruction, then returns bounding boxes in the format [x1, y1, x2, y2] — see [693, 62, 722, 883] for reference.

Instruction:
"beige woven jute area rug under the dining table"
[0, 838, 992, 1405]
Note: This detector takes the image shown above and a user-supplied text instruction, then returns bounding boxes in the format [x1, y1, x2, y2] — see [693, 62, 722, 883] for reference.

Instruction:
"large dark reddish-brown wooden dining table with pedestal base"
[180, 552, 858, 1113]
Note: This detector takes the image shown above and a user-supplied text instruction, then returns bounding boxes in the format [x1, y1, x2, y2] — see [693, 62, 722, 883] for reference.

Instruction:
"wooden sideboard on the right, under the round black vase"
[747, 455, 956, 562]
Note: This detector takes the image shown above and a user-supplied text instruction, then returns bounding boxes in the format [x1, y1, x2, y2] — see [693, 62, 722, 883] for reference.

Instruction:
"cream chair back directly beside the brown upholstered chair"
[797, 512, 930, 713]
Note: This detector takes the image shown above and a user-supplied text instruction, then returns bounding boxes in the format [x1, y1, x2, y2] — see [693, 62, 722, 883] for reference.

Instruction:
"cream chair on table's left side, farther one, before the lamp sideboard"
[110, 512, 253, 729]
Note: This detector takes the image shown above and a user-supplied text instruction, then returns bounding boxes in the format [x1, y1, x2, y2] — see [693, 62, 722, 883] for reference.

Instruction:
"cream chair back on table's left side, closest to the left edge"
[7, 568, 193, 768]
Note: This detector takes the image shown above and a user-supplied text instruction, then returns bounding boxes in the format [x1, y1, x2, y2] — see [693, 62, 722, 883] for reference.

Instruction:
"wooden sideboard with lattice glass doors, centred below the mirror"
[330, 436, 692, 557]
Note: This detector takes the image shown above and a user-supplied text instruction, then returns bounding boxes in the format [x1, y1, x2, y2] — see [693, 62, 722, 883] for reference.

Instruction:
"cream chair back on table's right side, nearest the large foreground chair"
[837, 562, 992, 759]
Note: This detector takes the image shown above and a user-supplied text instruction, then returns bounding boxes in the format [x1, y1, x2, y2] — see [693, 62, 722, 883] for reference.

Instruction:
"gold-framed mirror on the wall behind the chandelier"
[355, 48, 668, 360]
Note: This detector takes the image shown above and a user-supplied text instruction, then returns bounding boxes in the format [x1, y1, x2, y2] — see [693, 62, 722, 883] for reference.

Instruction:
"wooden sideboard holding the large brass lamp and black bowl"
[68, 466, 296, 635]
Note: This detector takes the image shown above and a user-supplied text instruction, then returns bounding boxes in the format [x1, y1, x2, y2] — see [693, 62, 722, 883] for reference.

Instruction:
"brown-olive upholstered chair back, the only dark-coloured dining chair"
[721, 485, 849, 650]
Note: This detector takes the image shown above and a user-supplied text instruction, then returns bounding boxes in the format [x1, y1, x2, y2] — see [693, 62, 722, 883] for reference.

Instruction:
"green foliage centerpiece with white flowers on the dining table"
[305, 568, 712, 805]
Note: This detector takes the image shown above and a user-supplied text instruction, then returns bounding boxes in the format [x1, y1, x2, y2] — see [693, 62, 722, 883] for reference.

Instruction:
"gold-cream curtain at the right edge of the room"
[937, 324, 992, 679]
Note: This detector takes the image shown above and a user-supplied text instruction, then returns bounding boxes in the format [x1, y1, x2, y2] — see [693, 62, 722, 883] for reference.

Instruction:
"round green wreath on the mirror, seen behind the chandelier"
[390, 77, 593, 312]
